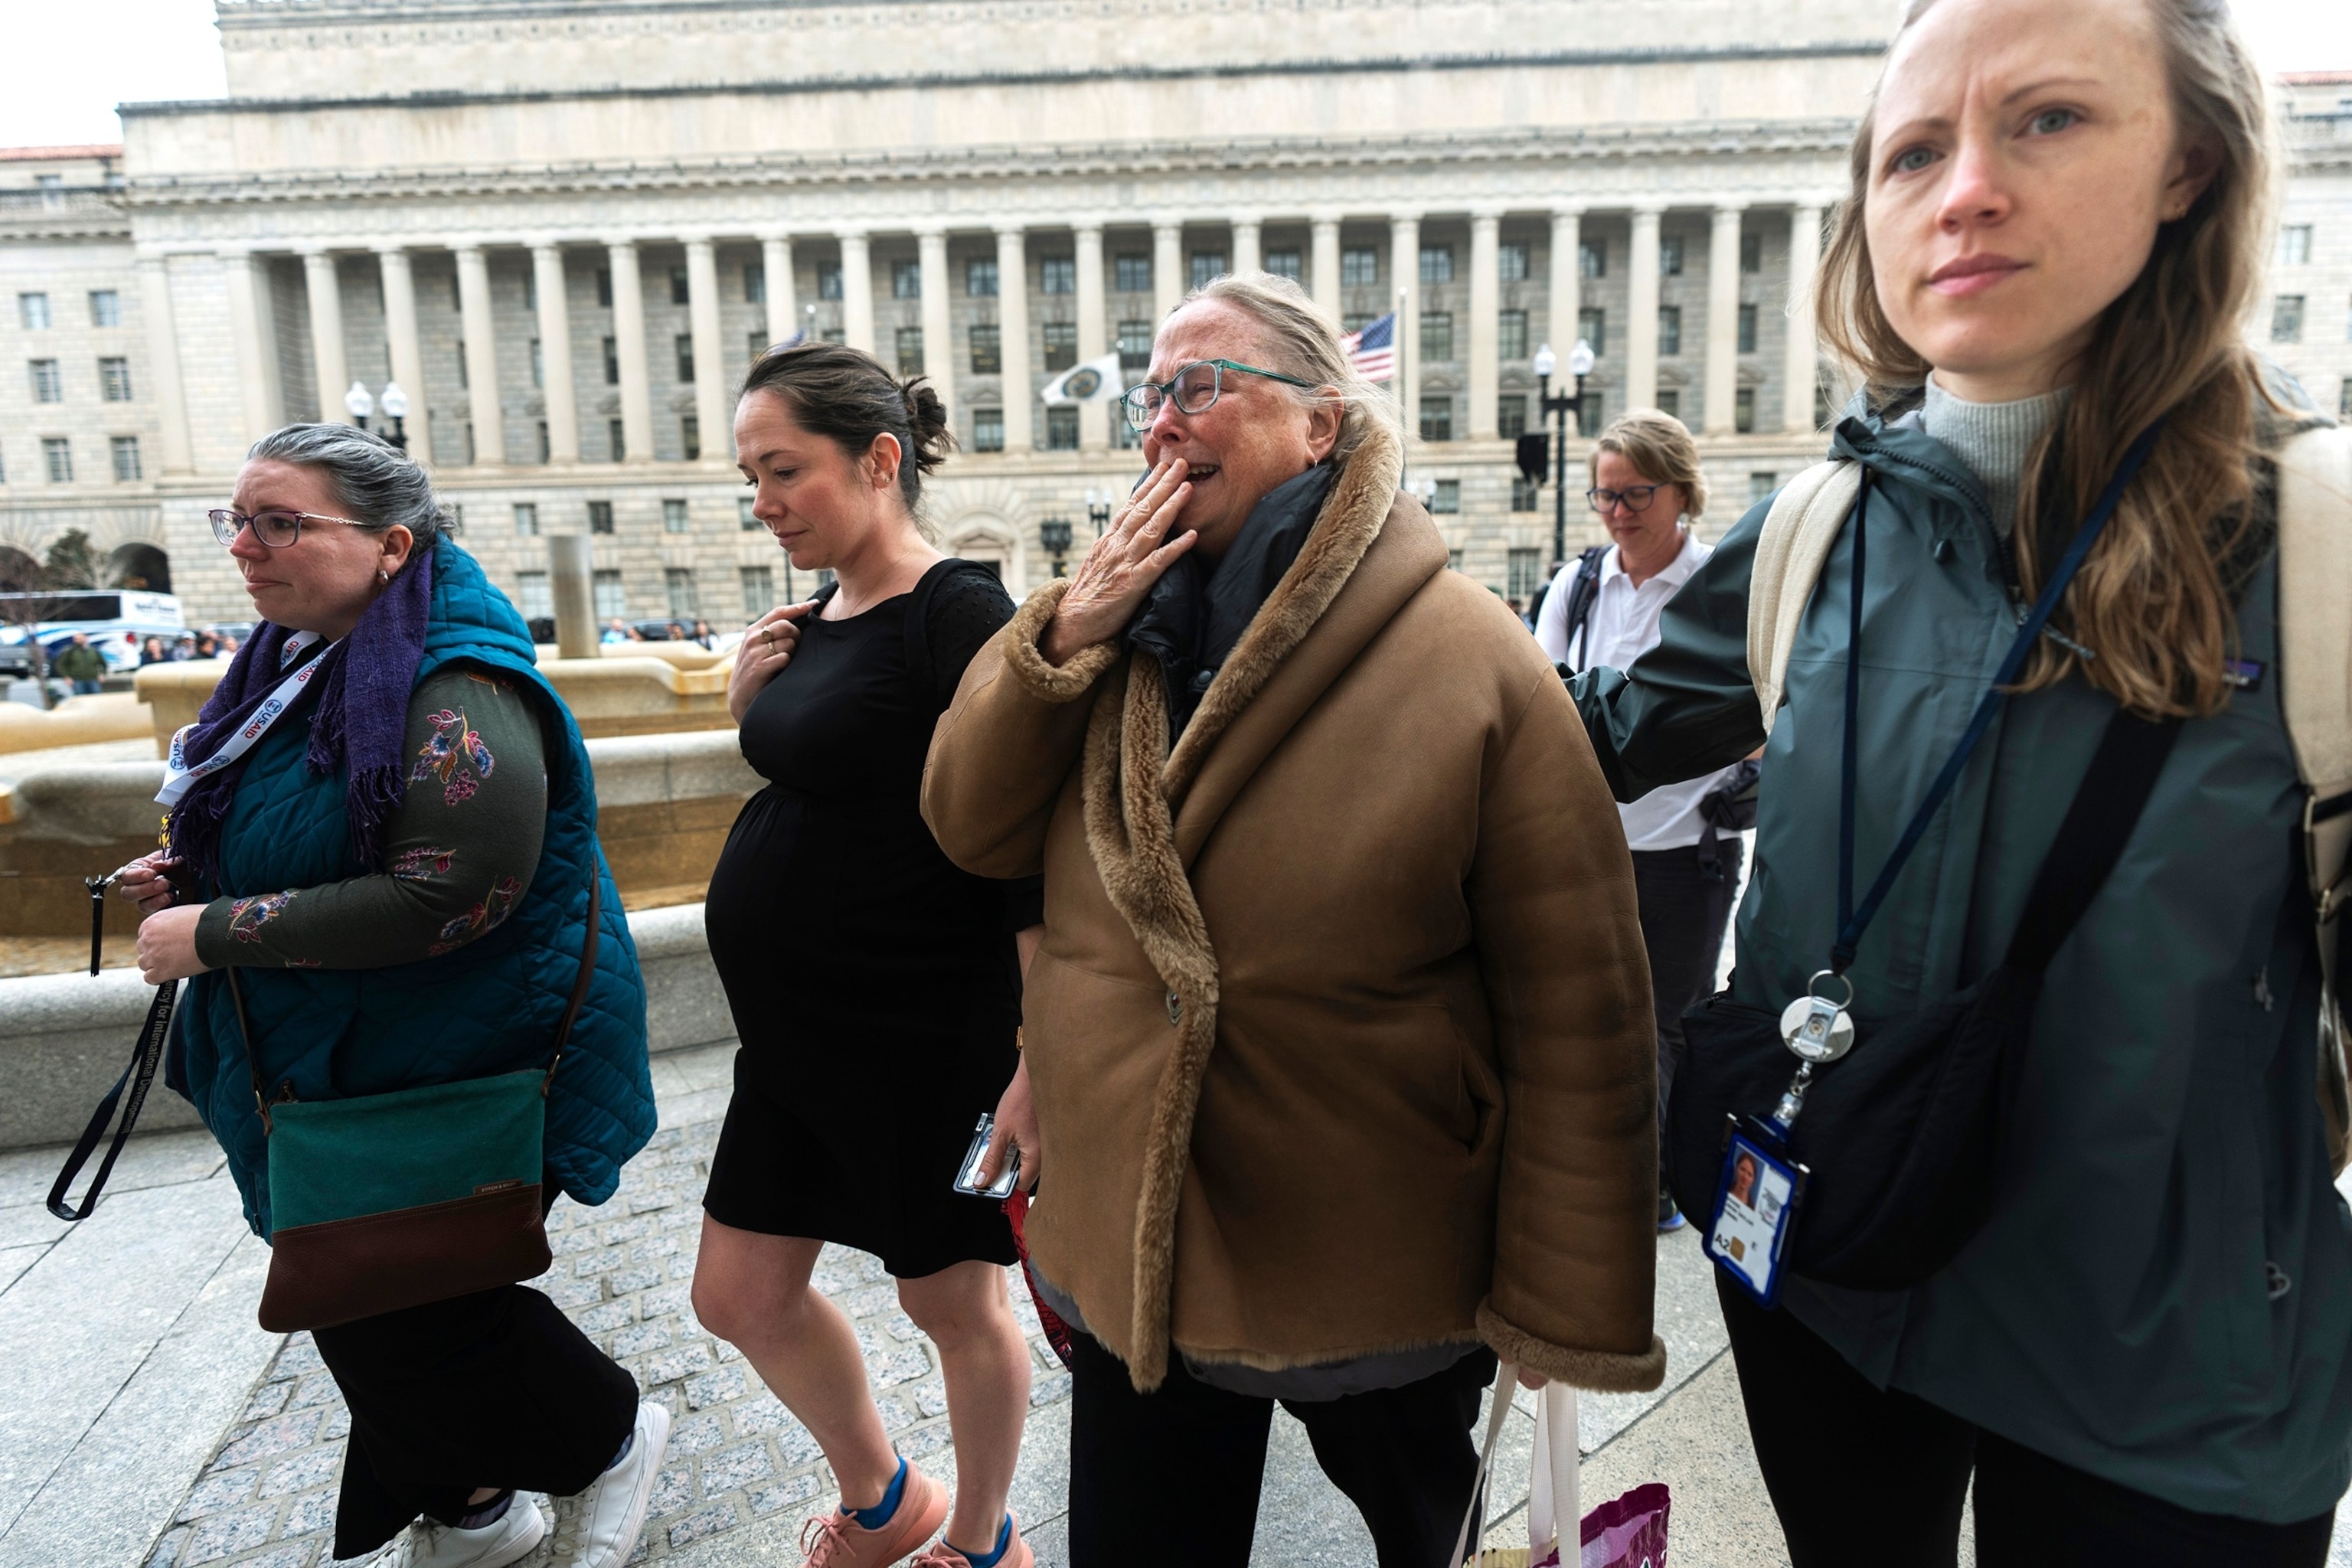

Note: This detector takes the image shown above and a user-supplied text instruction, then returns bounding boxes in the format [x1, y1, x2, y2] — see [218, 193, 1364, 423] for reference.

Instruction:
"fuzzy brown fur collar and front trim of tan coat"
[1076, 413, 1402, 1392]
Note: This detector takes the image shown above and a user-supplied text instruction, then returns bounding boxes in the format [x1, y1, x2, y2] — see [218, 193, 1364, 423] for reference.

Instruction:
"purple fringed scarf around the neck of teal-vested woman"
[167, 550, 433, 879]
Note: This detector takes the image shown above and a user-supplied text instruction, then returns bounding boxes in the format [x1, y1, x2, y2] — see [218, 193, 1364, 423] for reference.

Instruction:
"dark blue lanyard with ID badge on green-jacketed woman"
[1707, 421, 2164, 1305]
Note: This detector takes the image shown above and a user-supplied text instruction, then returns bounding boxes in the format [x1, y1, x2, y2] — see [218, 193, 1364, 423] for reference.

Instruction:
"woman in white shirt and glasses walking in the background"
[1536, 409, 1740, 1232]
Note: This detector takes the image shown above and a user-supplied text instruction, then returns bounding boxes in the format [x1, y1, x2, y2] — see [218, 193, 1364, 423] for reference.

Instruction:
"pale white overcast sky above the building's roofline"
[0, 0, 2352, 145]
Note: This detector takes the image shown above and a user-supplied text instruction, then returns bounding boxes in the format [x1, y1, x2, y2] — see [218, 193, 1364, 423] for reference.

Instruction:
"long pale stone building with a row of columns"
[0, 0, 2352, 623]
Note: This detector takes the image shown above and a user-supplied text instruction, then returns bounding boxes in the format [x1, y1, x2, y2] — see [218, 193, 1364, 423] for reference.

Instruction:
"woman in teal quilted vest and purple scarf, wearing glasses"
[122, 426, 668, 1568]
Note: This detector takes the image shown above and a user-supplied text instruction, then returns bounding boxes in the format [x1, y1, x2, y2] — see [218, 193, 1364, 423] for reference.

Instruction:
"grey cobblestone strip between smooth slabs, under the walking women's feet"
[149, 1096, 1070, 1568]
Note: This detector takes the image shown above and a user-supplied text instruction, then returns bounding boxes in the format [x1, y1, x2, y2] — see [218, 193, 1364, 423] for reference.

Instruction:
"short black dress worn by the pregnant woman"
[704, 560, 1042, 1279]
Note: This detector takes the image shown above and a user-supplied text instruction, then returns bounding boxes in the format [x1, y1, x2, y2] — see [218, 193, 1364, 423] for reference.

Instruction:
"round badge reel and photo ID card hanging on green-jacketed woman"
[1707, 969, 1854, 1307]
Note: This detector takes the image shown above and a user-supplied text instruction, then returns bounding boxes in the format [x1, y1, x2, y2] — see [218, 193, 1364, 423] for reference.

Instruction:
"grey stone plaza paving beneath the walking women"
[0, 1029, 2352, 1568]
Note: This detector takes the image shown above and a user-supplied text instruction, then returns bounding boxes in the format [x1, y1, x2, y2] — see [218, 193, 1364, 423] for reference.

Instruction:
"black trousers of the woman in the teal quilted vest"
[311, 1286, 638, 1559]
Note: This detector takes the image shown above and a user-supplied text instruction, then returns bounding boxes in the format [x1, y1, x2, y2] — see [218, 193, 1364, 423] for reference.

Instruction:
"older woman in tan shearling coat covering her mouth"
[922, 275, 1665, 1568]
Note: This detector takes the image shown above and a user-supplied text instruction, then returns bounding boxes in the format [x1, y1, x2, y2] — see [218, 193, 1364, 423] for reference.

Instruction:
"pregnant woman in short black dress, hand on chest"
[694, 343, 1042, 1568]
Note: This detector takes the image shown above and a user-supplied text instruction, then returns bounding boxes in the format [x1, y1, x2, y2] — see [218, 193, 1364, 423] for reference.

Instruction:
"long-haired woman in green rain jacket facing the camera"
[1573, 0, 2352, 1568]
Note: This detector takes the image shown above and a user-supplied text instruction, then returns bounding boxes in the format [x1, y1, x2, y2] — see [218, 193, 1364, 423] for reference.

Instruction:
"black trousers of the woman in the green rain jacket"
[1714, 1276, 2335, 1568]
